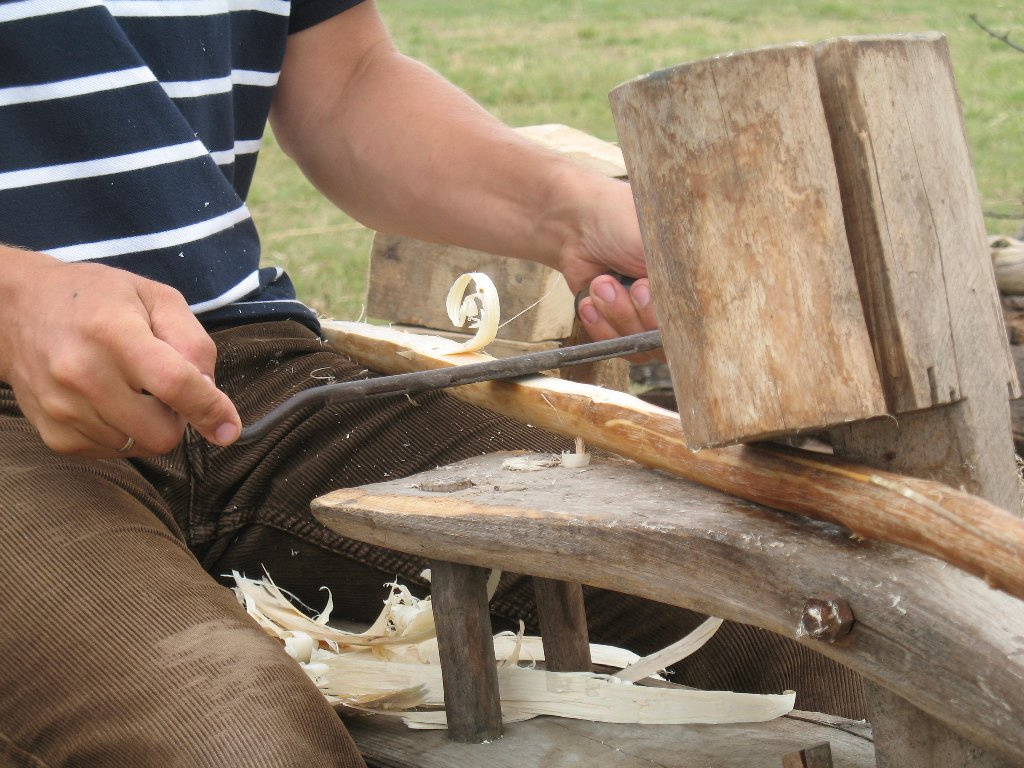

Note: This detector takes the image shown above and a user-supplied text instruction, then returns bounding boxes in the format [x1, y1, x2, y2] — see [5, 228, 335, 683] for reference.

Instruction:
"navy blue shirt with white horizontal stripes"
[0, 0, 359, 328]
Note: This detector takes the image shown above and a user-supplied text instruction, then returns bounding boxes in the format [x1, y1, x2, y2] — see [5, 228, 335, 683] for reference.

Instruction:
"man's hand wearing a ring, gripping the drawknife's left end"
[0, 246, 241, 458]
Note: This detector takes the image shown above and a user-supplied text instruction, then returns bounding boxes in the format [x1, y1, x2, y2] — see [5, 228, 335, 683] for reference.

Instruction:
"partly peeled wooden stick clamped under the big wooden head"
[324, 322, 1024, 599]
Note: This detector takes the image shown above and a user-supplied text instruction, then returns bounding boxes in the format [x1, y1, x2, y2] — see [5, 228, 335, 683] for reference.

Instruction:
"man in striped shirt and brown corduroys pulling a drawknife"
[0, 0, 864, 768]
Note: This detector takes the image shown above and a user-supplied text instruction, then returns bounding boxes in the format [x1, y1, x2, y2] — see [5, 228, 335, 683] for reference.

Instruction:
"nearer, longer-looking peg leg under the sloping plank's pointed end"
[430, 560, 502, 743]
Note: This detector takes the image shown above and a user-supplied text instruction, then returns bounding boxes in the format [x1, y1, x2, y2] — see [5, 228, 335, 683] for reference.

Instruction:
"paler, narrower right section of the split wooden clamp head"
[814, 34, 1020, 414]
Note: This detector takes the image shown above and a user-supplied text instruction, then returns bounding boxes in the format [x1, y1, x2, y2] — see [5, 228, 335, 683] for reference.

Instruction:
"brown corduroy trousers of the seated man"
[0, 322, 861, 768]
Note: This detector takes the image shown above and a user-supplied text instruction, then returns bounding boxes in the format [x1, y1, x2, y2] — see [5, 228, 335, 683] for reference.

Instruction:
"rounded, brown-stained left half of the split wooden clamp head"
[610, 45, 885, 449]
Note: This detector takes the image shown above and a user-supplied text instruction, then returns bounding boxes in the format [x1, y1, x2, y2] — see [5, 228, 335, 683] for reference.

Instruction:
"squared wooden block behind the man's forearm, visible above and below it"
[367, 124, 626, 342]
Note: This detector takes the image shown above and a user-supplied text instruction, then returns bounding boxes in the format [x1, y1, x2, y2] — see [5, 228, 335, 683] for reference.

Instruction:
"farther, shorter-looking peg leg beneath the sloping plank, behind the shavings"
[534, 577, 591, 672]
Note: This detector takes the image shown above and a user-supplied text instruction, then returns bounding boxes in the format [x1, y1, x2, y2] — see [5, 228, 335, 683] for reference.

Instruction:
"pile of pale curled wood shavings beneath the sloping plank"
[232, 572, 796, 728]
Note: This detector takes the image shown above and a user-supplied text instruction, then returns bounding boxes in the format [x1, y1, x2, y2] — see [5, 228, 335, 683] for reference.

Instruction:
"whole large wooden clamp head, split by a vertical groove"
[610, 35, 1016, 450]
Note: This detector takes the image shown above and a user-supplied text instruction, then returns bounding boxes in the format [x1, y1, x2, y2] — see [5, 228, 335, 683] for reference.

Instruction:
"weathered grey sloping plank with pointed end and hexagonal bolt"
[313, 454, 1024, 765]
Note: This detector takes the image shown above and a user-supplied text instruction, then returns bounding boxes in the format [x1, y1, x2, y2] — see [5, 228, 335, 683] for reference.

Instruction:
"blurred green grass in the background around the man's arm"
[250, 0, 1024, 318]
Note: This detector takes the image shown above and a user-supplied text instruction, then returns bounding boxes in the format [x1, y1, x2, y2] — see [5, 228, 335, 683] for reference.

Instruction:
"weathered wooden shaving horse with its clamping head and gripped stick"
[313, 35, 1024, 768]
